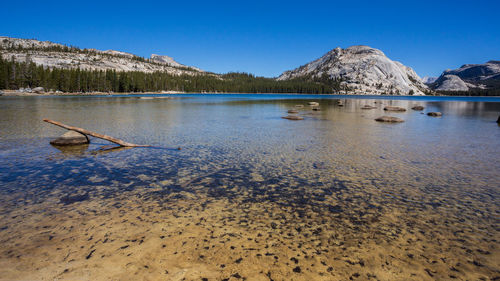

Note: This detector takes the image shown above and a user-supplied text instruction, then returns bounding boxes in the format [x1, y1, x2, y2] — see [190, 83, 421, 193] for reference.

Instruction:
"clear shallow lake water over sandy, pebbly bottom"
[0, 95, 500, 280]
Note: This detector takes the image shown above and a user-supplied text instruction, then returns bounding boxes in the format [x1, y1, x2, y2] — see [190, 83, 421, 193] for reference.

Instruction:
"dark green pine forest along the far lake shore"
[0, 53, 340, 94]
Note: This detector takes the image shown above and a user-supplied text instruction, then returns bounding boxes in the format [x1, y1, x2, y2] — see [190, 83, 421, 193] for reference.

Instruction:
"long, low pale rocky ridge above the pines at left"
[0, 36, 203, 75]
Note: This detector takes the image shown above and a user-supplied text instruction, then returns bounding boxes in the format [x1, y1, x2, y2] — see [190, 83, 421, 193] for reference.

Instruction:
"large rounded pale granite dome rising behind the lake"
[278, 46, 428, 95]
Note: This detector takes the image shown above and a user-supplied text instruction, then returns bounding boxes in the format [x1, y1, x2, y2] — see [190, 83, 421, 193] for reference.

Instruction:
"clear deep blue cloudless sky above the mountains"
[0, 0, 500, 77]
